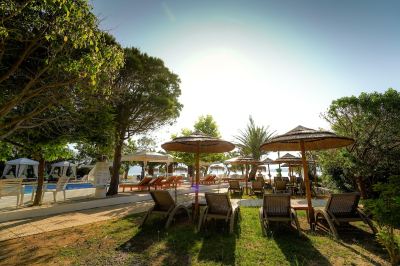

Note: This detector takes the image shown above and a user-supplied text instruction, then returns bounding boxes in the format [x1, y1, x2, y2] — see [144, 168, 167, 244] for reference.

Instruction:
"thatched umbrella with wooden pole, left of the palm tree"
[161, 133, 235, 214]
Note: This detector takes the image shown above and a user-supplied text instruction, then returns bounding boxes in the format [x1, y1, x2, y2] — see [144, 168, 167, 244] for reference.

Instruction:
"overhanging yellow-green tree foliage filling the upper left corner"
[0, 0, 123, 139]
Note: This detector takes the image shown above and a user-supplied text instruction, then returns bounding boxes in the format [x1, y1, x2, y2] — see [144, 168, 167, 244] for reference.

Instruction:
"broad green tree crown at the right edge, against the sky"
[324, 89, 400, 194]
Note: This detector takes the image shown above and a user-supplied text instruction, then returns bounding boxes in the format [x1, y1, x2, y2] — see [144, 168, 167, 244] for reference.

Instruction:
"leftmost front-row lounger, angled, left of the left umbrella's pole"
[140, 190, 190, 229]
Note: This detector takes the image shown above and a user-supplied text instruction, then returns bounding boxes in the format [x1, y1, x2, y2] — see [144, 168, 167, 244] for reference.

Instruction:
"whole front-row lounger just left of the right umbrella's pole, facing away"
[259, 194, 301, 235]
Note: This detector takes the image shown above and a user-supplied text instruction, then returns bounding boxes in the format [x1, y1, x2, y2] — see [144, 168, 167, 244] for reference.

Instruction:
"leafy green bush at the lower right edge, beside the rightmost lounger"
[367, 176, 400, 265]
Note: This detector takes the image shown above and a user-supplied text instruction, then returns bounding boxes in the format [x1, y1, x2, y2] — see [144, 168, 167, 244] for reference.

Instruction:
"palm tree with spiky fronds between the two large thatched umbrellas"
[234, 116, 275, 179]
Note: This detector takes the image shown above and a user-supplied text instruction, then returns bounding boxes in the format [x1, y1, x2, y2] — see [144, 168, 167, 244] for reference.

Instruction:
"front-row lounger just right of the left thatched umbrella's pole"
[197, 193, 239, 233]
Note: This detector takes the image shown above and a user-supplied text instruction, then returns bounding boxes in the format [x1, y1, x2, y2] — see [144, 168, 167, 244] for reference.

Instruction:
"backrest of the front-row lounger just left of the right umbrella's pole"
[263, 194, 290, 217]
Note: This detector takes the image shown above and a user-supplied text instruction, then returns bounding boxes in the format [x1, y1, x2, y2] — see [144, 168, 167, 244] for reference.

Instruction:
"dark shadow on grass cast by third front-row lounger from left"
[271, 224, 331, 265]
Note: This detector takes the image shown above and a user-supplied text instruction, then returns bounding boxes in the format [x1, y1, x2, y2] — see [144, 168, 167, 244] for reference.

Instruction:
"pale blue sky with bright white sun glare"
[91, 0, 400, 150]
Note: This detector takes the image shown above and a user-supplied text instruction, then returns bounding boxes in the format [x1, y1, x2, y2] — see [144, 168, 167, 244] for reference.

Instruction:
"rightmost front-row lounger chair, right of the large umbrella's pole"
[315, 192, 377, 239]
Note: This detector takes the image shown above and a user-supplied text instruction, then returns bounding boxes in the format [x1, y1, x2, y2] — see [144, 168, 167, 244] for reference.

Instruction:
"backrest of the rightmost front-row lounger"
[325, 192, 360, 217]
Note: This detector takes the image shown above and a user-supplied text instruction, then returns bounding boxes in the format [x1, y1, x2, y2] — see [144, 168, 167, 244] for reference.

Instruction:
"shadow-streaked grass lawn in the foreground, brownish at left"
[0, 207, 389, 265]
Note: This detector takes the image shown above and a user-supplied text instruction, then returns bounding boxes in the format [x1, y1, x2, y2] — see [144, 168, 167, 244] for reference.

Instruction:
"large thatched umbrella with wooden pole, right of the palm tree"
[260, 126, 354, 227]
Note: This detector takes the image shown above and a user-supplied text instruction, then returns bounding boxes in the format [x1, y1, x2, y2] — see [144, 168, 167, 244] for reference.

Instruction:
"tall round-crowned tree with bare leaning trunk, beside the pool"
[107, 47, 182, 195]
